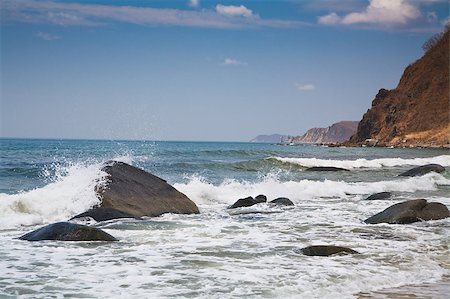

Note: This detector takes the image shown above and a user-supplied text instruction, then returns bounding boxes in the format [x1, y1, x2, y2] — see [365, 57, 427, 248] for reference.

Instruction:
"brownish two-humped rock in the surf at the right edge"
[364, 199, 450, 224]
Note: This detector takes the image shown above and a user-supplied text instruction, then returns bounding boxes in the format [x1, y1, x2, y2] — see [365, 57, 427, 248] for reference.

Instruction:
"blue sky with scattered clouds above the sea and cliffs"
[0, 0, 449, 141]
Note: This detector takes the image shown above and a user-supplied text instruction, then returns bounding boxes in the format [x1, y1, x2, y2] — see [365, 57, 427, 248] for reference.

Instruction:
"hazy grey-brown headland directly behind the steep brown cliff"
[290, 121, 359, 143]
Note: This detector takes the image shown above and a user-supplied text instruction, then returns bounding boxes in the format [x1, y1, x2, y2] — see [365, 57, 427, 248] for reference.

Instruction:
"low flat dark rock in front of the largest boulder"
[19, 222, 117, 241]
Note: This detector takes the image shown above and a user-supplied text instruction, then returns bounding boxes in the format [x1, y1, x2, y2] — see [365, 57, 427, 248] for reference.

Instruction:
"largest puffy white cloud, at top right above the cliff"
[319, 0, 421, 25]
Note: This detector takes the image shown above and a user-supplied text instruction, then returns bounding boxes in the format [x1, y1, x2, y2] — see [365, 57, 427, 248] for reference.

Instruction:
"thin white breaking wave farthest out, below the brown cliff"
[267, 155, 450, 169]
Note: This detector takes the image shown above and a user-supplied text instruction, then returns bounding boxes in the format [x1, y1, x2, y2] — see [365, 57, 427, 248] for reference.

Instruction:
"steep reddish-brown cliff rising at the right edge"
[349, 30, 450, 147]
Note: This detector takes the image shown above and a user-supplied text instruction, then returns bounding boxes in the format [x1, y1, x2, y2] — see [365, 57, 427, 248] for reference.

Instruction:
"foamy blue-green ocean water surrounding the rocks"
[0, 139, 450, 298]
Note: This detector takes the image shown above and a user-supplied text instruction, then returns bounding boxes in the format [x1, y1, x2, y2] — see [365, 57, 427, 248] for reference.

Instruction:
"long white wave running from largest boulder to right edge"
[174, 173, 450, 205]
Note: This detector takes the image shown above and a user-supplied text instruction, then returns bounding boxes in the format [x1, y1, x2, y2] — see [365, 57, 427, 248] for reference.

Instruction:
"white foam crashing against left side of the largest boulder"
[0, 163, 107, 228]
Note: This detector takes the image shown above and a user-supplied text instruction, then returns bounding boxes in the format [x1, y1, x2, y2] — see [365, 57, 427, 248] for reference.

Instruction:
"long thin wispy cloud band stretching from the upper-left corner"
[2, 0, 305, 29]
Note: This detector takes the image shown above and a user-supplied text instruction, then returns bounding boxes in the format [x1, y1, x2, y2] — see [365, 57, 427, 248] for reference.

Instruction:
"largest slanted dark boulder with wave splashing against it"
[97, 161, 199, 217]
